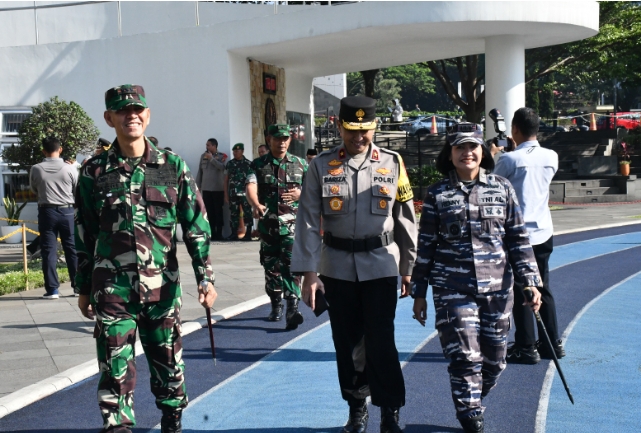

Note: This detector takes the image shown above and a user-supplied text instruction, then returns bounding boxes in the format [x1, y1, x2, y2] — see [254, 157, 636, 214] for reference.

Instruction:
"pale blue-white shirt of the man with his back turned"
[493, 140, 559, 245]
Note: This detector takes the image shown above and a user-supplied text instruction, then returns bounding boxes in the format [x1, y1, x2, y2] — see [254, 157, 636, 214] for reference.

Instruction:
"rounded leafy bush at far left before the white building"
[2, 96, 99, 171]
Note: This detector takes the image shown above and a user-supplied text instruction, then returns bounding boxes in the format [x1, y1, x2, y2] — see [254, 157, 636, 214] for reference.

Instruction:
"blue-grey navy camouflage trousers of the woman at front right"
[433, 287, 514, 419]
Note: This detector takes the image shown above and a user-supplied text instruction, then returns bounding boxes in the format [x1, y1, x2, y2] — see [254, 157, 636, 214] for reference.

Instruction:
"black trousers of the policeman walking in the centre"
[320, 275, 405, 407]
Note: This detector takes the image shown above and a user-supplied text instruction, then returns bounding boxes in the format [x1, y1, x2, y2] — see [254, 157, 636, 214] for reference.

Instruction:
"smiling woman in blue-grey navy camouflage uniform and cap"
[412, 123, 541, 433]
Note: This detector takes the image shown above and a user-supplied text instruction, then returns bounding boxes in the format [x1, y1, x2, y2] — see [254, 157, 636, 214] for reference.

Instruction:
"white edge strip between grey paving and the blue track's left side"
[0, 295, 269, 418]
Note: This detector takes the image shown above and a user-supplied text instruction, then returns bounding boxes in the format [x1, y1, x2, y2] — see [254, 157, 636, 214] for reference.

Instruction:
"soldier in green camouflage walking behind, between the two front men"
[247, 125, 307, 329]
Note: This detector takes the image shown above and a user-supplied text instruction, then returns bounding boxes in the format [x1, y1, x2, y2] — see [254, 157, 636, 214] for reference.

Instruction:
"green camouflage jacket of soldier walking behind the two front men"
[247, 152, 307, 235]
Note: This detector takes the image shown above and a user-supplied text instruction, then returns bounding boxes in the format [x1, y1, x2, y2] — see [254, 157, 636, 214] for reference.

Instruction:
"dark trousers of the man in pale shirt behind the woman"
[512, 236, 559, 347]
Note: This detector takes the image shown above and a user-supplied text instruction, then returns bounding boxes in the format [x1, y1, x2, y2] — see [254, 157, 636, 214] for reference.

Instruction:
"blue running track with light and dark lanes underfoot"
[0, 225, 641, 433]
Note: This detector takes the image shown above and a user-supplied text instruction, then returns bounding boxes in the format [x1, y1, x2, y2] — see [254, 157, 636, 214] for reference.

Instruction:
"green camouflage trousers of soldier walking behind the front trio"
[258, 220, 301, 299]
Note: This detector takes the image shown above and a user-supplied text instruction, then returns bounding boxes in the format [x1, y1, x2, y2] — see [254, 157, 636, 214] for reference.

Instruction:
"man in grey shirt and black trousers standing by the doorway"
[196, 138, 227, 241]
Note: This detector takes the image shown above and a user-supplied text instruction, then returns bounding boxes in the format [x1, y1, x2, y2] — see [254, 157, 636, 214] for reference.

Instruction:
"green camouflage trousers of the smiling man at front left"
[94, 298, 187, 430]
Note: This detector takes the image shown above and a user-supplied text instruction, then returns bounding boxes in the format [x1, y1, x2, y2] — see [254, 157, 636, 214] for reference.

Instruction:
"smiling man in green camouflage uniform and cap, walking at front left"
[75, 85, 216, 433]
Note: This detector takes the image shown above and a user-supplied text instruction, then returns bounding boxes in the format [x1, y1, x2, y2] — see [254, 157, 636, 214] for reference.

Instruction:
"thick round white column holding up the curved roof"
[485, 35, 525, 138]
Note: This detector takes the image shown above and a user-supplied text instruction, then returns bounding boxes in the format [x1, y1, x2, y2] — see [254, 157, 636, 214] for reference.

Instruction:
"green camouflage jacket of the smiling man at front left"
[75, 141, 214, 303]
